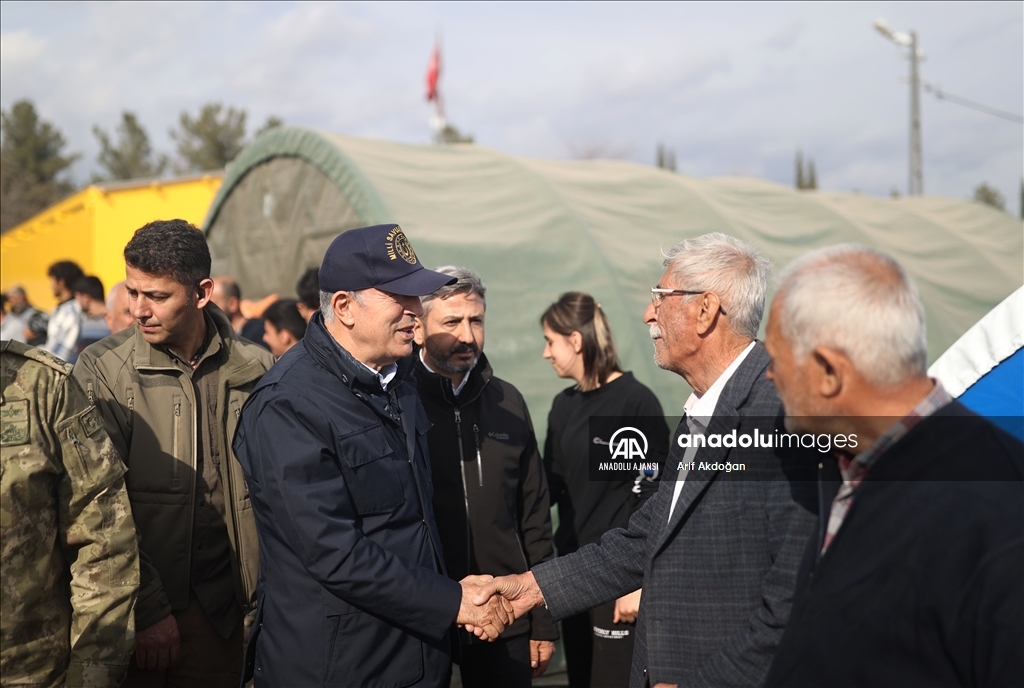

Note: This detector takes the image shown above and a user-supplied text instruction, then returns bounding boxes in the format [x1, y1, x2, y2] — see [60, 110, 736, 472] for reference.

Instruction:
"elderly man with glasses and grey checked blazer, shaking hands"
[468, 233, 814, 688]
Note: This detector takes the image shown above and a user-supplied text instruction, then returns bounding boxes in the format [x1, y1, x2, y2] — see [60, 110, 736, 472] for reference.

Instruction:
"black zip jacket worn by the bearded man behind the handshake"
[415, 354, 558, 640]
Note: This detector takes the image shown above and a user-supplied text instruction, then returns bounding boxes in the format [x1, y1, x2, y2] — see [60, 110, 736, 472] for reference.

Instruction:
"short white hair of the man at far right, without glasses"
[777, 244, 928, 387]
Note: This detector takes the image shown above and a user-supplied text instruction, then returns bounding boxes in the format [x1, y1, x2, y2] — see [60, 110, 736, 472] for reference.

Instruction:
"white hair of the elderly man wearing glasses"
[665, 231, 771, 339]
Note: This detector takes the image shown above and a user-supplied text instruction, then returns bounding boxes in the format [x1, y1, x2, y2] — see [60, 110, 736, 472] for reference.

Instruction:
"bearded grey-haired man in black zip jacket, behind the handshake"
[415, 265, 558, 688]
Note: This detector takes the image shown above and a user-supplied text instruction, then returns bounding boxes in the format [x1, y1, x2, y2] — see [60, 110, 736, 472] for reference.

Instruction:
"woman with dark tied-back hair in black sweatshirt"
[541, 292, 669, 688]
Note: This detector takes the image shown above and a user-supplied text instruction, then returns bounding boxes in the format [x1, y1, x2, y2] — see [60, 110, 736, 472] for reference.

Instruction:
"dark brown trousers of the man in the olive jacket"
[121, 596, 243, 688]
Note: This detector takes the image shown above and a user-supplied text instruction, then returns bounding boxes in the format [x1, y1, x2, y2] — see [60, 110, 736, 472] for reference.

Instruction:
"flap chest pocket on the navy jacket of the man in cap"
[338, 426, 404, 516]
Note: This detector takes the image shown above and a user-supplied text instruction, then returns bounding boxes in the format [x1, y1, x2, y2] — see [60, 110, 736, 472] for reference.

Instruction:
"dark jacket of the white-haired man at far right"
[767, 401, 1024, 687]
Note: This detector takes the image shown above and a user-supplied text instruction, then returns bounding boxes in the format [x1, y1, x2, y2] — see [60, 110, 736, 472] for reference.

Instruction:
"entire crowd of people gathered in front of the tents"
[0, 220, 1024, 688]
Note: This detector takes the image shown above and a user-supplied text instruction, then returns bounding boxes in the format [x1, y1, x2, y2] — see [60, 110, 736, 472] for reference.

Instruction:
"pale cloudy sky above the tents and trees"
[0, 2, 1024, 207]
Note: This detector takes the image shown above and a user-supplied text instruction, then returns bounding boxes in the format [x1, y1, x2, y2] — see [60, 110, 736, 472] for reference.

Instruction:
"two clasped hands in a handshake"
[456, 571, 544, 641]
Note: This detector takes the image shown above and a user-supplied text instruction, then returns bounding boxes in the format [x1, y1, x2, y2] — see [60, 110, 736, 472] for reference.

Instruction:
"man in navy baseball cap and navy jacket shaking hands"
[234, 224, 512, 687]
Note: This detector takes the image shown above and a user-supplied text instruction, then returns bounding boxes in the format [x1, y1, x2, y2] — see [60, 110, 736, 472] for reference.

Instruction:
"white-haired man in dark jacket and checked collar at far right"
[766, 245, 1024, 687]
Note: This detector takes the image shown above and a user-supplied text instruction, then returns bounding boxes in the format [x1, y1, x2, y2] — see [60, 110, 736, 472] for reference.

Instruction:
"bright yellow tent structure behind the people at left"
[0, 171, 223, 310]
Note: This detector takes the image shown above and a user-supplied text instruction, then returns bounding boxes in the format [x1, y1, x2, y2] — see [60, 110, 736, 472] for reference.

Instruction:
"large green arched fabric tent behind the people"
[204, 127, 1024, 437]
